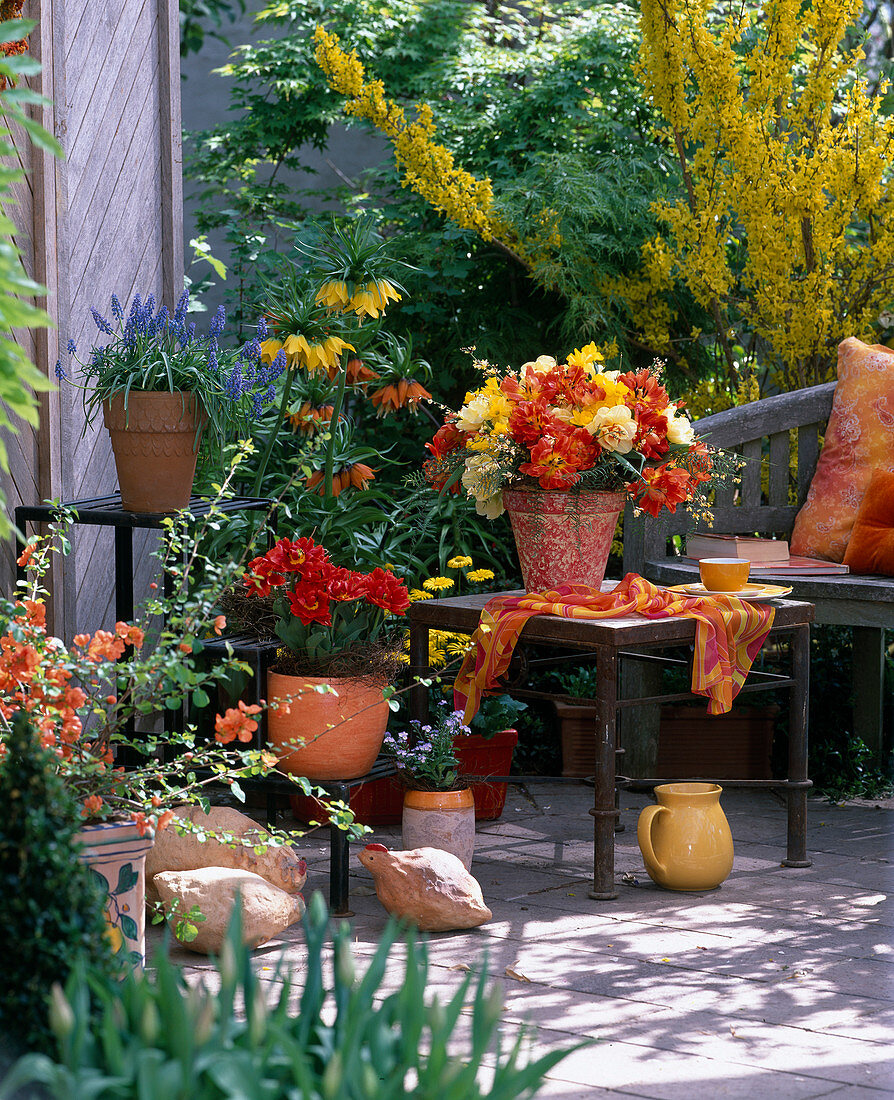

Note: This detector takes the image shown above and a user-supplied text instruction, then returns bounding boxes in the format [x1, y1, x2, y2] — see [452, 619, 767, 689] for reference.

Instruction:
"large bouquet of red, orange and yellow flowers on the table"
[423, 343, 724, 519]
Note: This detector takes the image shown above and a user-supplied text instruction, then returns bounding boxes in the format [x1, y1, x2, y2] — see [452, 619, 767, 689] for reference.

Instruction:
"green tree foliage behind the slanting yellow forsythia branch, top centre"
[188, 0, 669, 369]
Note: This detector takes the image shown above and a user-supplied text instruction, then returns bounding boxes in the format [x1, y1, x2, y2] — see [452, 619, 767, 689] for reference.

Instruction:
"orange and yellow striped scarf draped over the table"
[453, 573, 775, 722]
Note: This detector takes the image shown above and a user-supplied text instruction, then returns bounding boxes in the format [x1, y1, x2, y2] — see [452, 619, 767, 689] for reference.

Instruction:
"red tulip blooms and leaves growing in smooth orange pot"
[243, 538, 410, 675]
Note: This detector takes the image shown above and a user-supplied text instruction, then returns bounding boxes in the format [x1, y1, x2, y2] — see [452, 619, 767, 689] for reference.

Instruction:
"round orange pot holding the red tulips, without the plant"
[267, 672, 389, 783]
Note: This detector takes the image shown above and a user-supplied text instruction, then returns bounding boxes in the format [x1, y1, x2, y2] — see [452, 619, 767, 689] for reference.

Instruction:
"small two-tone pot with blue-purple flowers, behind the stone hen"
[383, 702, 475, 869]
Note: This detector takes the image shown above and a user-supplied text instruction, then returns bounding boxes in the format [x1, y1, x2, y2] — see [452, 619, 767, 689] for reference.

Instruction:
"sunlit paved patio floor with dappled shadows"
[150, 783, 894, 1100]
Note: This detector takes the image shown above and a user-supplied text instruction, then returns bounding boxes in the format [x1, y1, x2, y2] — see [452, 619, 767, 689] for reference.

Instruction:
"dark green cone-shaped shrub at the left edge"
[0, 714, 114, 1065]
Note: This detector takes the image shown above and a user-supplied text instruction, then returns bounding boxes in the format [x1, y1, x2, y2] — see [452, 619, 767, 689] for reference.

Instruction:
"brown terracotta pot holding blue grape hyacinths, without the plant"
[102, 391, 208, 513]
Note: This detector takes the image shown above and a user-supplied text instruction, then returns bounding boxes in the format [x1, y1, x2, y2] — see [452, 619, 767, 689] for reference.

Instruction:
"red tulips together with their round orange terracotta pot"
[223, 538, 410, 782]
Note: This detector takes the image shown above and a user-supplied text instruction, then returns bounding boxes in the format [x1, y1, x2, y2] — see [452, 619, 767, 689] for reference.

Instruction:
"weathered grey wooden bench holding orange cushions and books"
[623, 382, 894, 761]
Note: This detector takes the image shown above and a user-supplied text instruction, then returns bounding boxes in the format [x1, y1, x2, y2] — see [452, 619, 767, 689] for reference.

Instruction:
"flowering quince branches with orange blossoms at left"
[0, 448, 361, 836]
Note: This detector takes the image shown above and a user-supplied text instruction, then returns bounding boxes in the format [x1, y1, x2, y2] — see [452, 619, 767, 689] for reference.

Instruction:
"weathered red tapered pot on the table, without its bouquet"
[503, 488, 627, 592]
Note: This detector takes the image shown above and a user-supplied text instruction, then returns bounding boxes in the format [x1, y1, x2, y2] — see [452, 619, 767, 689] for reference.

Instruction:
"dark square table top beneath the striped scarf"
[409, 581, 814, 647]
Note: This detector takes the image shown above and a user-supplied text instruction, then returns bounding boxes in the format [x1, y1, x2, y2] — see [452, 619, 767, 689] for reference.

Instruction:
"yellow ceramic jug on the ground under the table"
[637, 783, 732, 890]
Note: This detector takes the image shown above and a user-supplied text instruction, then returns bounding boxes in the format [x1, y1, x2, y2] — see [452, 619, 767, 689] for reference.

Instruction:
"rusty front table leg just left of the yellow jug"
[589, 648, 618, 901]
